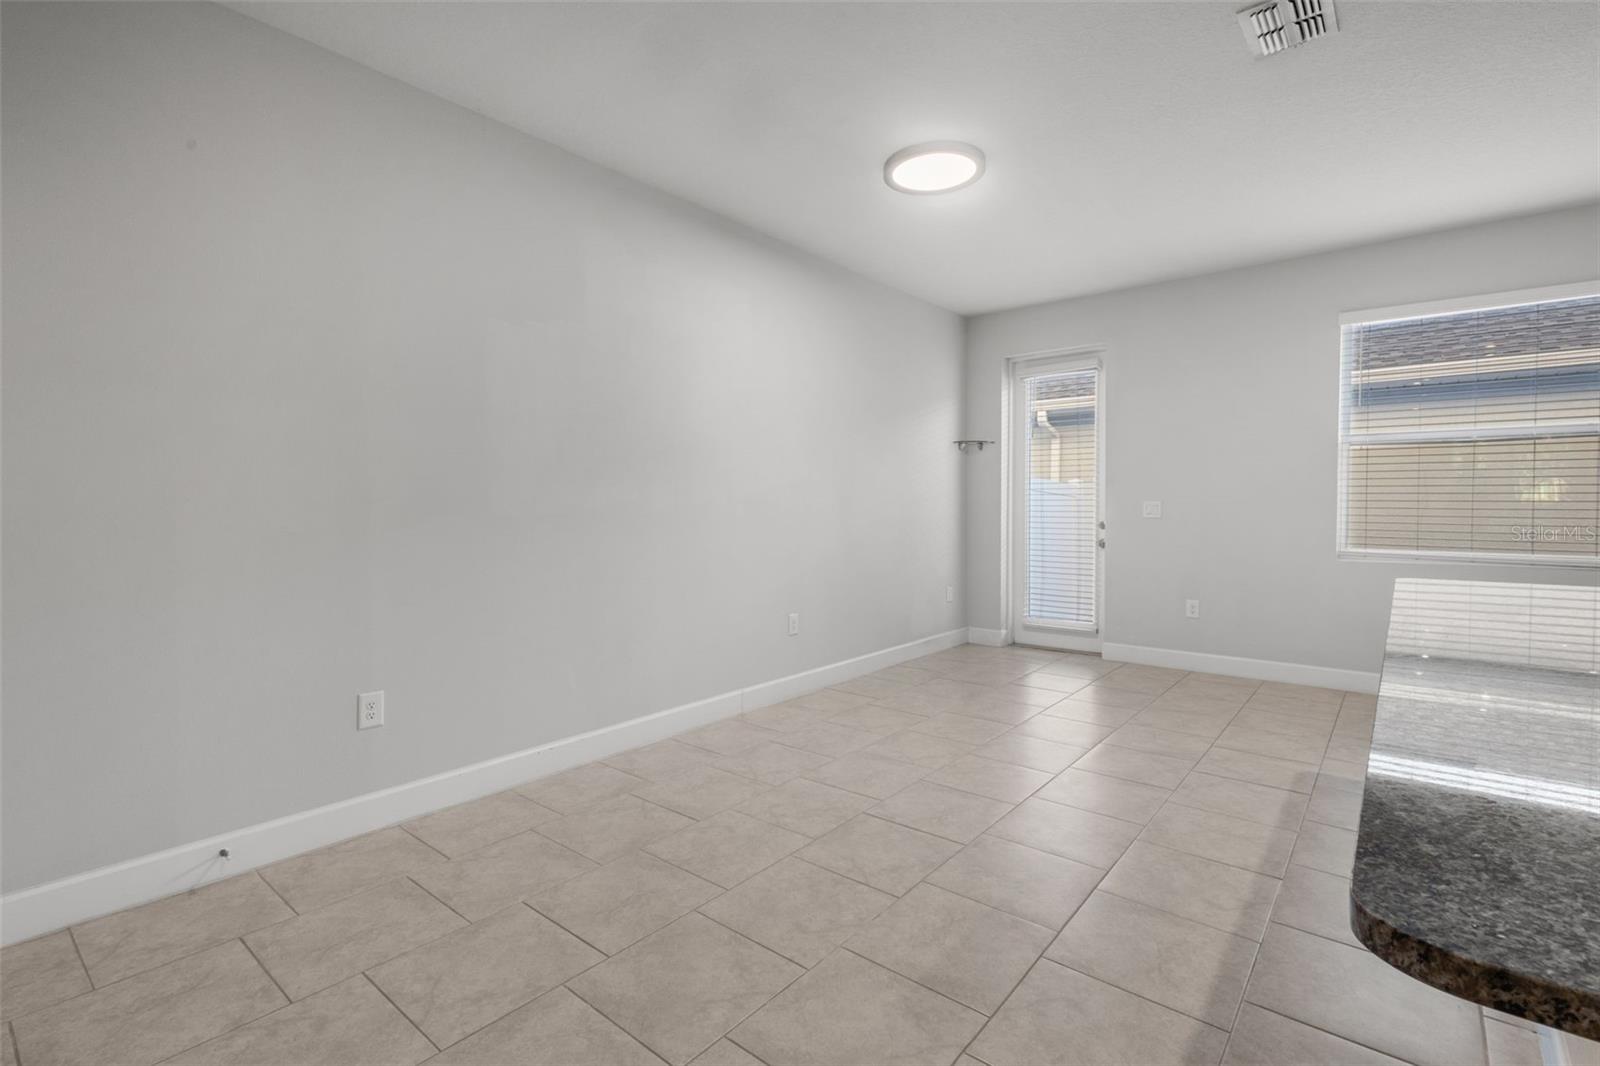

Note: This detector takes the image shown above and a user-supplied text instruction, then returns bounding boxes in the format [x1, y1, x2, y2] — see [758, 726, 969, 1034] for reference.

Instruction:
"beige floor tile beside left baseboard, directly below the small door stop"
[72, 872, 294, 986]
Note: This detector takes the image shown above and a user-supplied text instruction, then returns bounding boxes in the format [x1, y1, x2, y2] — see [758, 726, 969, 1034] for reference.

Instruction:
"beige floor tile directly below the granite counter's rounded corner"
[1245, 925, 1485, 1066]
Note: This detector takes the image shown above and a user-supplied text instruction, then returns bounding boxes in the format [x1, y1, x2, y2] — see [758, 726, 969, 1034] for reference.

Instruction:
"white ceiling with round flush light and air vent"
[230, 0, 1600, 314]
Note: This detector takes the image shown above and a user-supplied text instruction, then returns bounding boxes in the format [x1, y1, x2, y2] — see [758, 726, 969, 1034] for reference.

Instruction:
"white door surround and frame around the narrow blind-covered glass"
[1000, 344, 1107, 651]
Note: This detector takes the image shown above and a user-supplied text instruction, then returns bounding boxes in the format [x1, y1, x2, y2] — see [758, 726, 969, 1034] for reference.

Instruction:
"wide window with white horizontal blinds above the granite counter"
[1339, 287, 1600, 565]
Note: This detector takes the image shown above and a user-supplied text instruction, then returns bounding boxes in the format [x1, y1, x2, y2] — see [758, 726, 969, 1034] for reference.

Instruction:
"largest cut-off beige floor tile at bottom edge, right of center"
[973, 959, 1227, 1066]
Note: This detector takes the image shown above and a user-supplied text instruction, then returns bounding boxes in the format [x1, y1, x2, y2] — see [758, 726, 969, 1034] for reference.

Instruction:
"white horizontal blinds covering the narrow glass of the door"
[1024, 368, 1099, 631]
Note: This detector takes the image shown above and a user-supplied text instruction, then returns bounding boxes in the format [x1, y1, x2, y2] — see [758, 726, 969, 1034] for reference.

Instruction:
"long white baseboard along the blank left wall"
[0, 629, 966, 944]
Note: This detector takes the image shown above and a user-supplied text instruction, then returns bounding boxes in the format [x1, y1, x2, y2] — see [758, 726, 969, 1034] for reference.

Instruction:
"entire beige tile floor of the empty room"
[0, 645, 1593, 1066]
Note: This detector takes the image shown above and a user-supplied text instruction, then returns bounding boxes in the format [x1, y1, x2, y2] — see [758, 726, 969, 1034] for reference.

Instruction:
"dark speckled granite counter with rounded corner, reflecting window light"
[1350, 579, 1600, 1039]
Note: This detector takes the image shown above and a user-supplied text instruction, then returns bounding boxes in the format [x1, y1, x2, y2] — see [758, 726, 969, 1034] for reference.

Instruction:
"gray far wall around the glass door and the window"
[966, 206, 1600, 672]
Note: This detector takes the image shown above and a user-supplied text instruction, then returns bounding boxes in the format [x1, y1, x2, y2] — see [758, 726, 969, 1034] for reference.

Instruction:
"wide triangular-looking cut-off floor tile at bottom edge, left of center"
[429, 988, 661, 1066]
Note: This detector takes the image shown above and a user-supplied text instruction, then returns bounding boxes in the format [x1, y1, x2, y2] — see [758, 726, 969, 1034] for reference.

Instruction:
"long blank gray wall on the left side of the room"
[3, 3, 963, 890]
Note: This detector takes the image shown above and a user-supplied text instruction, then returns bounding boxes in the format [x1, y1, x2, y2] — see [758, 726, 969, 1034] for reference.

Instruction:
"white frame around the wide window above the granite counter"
[1333, 279, 1600, 570]
